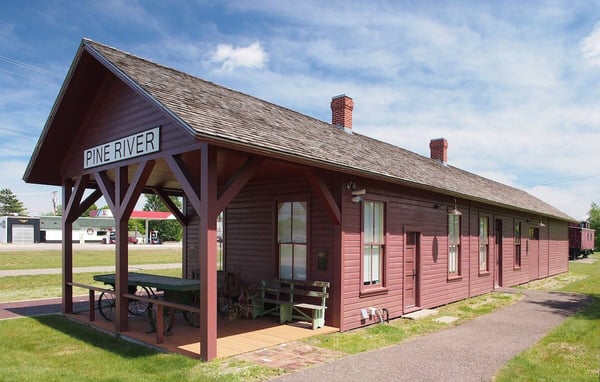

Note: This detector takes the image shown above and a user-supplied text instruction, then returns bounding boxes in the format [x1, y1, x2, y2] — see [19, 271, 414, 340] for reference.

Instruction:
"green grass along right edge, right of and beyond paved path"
[495, 254, 600, 382]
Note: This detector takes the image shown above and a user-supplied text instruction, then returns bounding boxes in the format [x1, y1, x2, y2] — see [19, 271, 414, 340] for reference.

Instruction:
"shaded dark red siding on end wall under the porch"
[185, 165, 339, 325]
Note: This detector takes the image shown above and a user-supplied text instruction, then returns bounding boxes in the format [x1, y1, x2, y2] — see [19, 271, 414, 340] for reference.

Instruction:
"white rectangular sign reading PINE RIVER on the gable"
[83, 126, 160, 169]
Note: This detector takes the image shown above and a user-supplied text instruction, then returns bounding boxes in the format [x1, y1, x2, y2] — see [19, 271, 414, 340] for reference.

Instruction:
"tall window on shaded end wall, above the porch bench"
[277, 201, 308, 280]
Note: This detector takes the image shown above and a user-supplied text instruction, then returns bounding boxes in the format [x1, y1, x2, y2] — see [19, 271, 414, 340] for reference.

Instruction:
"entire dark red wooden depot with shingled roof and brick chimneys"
[24, 39, 573, 360]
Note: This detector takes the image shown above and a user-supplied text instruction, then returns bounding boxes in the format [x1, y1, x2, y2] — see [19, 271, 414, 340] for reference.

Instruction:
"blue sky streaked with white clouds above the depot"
[0, 0, 600, 219]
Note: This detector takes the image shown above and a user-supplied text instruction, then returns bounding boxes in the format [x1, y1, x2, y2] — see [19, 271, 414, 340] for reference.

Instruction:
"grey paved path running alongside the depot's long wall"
[275, 289, 591, 382]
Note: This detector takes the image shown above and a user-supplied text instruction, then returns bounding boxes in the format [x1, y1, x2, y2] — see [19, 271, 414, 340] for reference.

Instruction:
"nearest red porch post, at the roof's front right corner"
[198, 144, 217, 361]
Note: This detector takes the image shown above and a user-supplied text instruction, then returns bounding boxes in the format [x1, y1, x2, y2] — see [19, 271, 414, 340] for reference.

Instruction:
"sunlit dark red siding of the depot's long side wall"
[340, 180, 568, 330]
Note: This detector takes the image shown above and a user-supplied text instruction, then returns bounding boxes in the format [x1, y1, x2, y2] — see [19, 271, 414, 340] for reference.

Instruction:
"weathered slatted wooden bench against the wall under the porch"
[251, 279, 330, 329]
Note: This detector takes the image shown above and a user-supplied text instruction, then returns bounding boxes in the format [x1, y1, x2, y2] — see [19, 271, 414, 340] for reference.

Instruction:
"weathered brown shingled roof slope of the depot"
[52, 39, 574, 221]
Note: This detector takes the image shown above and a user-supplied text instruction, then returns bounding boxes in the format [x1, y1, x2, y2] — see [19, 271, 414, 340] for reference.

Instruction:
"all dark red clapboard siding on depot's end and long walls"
[186, 166, 568, 330]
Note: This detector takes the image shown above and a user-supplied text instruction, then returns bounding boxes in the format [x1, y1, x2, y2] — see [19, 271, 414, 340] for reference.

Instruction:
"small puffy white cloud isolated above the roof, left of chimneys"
[211, 41, 268, 70]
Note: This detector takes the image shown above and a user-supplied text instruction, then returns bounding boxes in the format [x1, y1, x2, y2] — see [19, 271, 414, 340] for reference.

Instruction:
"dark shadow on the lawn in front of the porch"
[31, 315, 159, 359]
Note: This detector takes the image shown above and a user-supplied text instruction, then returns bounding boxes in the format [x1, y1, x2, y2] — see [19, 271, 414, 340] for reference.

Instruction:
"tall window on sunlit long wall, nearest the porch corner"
[362, 201, 385, 285]
